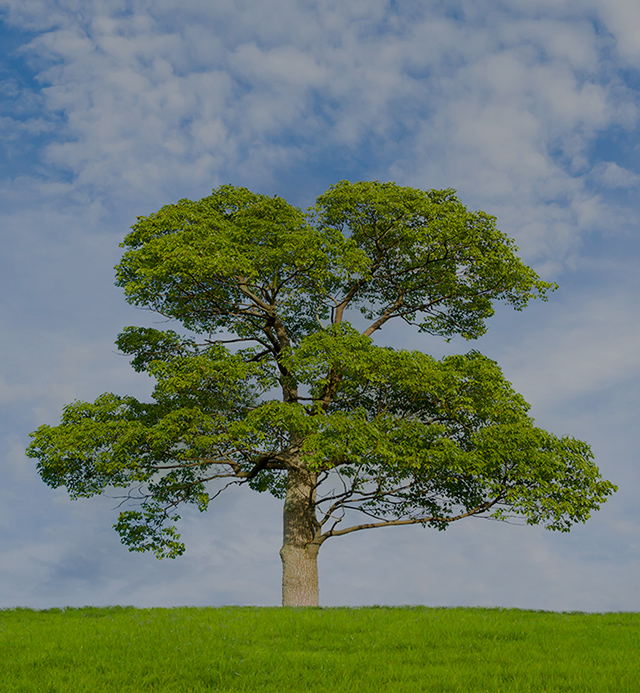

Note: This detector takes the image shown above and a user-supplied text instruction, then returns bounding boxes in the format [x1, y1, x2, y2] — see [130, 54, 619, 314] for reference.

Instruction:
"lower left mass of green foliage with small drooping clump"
[27, 328, 282, 558]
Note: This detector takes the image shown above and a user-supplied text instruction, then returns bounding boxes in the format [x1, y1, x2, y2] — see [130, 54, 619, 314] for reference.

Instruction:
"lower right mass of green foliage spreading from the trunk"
[288, 324, 615, 530]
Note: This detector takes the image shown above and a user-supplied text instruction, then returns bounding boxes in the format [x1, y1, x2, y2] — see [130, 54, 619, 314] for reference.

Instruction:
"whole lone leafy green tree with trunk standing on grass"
[27, 181, 615, 606]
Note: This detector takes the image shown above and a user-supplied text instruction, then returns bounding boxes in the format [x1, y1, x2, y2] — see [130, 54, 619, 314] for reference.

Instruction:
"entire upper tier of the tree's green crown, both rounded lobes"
[117, 181, 555, 342]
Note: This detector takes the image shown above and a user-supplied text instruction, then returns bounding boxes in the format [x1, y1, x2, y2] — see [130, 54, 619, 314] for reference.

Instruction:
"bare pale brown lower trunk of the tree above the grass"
[280, 469, 320, 606]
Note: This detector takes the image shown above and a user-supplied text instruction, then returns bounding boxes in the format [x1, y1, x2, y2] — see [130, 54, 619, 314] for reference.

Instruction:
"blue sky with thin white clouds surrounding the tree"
[0, 0, 640, 611]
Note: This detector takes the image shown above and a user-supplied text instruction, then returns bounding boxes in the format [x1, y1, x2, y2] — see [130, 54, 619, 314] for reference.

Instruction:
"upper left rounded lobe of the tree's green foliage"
[117, 186, 365, 337]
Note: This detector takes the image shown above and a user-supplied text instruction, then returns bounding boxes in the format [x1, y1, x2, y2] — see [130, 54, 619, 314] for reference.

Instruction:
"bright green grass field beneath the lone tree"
[0, 607, 640, 693]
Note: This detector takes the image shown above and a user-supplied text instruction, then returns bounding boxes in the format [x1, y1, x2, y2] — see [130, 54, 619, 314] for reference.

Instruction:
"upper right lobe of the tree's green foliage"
[314, 181, 555, 339]
